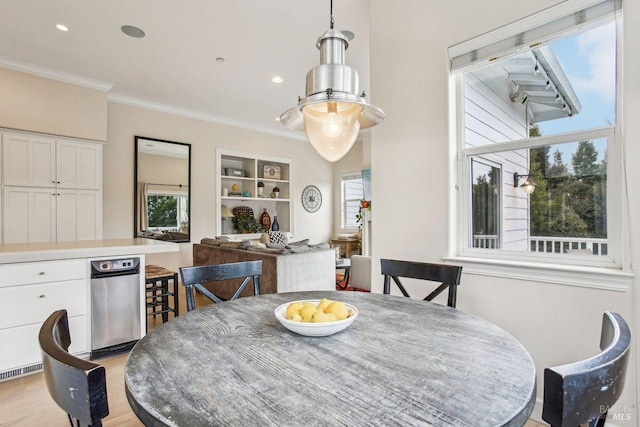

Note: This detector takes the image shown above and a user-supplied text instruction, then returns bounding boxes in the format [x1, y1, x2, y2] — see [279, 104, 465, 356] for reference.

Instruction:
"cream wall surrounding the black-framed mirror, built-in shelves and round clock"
[103, 102, 334, 269]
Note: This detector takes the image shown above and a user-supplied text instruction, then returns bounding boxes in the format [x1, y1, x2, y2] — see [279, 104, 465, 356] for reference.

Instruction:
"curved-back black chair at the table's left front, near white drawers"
[38, 310, 109, 427]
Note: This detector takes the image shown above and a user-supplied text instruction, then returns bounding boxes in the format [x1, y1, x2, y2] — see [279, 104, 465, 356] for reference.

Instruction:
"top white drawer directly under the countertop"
[0, 259, 89, 288]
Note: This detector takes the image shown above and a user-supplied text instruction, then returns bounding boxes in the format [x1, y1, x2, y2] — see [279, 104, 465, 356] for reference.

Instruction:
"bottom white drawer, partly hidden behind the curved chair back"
[0, 313, 89, 372]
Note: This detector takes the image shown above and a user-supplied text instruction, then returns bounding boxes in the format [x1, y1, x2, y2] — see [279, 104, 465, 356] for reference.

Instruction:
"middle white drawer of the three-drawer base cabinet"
[0, 279, 87, 330]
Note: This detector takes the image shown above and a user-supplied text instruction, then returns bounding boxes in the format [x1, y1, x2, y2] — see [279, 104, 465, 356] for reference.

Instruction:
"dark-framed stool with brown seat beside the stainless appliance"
[144, 265, 180, 323]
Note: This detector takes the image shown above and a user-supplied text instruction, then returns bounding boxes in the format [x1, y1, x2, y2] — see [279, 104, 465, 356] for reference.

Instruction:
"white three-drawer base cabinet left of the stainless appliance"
[0, 259, 89, 378]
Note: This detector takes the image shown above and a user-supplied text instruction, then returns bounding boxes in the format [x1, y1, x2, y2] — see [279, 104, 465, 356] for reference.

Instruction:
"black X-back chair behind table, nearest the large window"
[380, 259, 462, 308]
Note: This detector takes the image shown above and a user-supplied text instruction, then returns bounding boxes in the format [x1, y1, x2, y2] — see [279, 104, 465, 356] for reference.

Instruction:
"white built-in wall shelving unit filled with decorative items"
[216, 149, 293, 239]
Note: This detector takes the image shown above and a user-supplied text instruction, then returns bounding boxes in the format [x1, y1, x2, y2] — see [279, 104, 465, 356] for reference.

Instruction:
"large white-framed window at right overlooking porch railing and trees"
[449, 0, 622, 266]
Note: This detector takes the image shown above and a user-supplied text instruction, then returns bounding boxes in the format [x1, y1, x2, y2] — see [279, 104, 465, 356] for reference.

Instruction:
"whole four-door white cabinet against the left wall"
[2, 133, 102, 243]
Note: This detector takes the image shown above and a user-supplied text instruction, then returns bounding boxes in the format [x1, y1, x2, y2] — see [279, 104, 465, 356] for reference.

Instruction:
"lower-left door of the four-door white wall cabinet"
[3, 186, 56, 243]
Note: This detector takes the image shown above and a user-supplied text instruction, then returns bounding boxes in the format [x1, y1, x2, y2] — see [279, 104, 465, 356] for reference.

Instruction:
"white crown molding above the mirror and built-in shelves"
[107, 94, 307, 141]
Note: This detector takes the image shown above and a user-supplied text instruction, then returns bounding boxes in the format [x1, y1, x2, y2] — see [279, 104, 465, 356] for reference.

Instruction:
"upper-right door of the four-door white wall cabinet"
[56, 141, 102, 190]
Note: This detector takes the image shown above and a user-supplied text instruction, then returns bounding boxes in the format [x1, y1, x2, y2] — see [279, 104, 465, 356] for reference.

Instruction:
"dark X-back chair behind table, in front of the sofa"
[180, 260, 262, 311]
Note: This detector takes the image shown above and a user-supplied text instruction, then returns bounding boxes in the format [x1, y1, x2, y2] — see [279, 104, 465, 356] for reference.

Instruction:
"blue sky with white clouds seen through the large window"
[538, 23, 616, 165]
